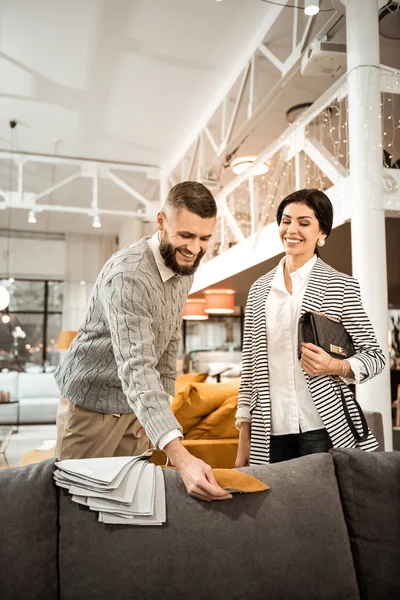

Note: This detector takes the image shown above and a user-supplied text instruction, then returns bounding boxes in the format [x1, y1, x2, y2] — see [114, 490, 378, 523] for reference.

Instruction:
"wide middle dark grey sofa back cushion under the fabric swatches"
[60, 454, 359, 600]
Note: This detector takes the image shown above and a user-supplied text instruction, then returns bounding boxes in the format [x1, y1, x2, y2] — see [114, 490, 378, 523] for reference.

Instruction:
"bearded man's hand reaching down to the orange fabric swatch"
[164, 439, 232, 502]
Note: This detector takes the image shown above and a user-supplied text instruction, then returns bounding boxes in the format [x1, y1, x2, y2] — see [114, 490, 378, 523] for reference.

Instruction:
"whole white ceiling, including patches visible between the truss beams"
[0, 0, 398, 234]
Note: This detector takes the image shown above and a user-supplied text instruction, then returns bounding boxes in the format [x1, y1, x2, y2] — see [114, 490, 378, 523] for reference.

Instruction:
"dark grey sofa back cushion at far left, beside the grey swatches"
[0, 460, 59, 600]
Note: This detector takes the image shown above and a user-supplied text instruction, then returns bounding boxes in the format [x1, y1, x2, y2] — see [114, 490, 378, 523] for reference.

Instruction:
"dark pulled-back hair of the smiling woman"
[276, 188, 333, 256]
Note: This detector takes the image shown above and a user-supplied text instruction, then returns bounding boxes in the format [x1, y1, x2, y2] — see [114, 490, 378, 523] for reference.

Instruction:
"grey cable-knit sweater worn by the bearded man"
[55, 238, 193, 444]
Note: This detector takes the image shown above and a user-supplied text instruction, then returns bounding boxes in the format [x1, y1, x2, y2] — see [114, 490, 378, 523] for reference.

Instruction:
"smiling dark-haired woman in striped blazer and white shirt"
[236, 189, 385, 467]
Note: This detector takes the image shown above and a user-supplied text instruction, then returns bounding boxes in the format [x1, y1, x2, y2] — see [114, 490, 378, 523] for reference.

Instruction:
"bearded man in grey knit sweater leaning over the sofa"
[55, 181, 230, 501]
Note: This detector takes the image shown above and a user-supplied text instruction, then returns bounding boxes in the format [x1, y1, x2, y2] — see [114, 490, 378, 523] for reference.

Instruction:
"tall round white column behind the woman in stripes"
[342, 0, 393, 450]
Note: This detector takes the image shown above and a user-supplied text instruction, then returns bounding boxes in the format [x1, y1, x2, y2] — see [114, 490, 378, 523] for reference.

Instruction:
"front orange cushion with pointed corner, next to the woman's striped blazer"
[185, 395, 239, 440]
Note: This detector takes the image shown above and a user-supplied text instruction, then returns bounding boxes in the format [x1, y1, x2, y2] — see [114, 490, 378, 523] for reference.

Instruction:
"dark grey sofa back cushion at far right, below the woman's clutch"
[331, 448, 400, 600]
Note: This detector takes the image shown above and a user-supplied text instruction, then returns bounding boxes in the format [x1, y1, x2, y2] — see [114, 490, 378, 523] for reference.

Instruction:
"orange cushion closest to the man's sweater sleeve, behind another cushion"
[171, 378, 240, 434]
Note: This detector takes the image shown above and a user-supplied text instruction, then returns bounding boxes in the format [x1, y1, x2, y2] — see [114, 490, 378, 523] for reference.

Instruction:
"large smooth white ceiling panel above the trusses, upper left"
[0, 0, 280, 165]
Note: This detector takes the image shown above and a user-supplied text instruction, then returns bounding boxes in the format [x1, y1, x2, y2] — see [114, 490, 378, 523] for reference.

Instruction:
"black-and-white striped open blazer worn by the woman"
[238, 258, 385, 465]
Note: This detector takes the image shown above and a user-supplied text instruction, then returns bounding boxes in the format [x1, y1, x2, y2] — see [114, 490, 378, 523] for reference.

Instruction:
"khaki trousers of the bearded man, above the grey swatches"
[56, 396, 150, 460]
